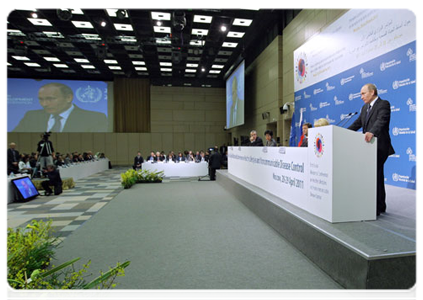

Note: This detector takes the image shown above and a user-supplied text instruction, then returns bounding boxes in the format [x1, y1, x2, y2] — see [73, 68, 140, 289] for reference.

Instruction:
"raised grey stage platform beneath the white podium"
[217, 170, 420, 300]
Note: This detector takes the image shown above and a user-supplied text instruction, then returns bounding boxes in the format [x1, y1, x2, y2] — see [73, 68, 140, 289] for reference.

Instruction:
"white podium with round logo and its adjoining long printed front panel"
[228, 126, 377, 223]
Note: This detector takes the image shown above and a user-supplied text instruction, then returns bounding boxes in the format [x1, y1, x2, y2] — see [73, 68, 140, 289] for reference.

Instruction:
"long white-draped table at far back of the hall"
[142, 162, 208, 177]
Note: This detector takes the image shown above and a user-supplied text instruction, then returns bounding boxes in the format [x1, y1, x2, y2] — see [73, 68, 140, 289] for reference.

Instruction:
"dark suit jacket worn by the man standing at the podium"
[348, 98, 395, 156]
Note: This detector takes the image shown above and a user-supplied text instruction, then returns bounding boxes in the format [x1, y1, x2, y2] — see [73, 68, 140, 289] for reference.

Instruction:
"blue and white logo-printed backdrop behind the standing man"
[294, 9, 420, 190]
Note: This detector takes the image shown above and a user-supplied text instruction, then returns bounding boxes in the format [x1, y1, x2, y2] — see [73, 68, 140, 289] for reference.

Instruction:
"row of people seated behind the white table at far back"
[133, 150, 228, 169]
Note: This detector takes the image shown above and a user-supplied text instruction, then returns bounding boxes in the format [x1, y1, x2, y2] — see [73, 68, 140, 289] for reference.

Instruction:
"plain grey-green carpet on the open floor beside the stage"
[51, 182, 354, 300]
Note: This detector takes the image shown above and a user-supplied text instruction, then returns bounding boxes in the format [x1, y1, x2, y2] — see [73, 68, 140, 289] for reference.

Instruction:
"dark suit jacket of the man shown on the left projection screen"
[13, 105, 108, 132]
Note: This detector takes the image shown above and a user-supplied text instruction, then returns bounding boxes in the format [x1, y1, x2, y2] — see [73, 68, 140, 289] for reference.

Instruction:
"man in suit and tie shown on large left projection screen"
[13, 83, 108, 132]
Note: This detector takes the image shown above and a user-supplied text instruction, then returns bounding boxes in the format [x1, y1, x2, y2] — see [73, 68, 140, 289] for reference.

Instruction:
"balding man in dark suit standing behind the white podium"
[348, 83, 395, 215]
